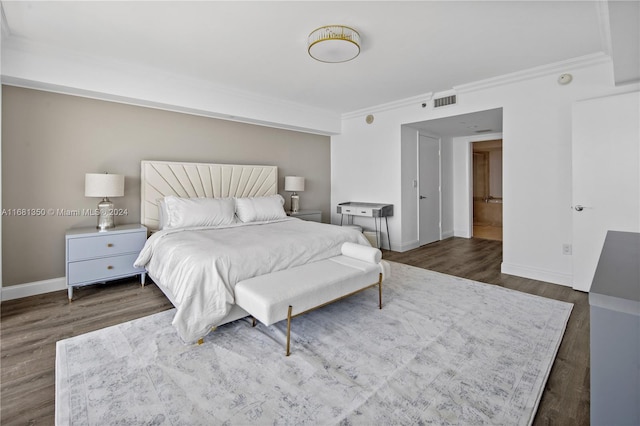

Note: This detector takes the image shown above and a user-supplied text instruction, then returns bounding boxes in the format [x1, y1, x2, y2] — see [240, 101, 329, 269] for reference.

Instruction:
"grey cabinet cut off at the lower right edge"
[589, 231, 640, 425]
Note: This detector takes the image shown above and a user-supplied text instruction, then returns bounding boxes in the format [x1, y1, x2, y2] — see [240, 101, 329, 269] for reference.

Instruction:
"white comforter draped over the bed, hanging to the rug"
[135, 218, 370, 343]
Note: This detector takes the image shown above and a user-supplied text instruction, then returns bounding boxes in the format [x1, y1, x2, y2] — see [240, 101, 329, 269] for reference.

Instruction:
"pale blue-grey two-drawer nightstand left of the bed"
[65, 225, 147, 301]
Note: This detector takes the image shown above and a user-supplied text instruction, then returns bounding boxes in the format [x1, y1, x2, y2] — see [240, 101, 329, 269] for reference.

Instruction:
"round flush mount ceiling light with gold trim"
[308, 25, 360, 63]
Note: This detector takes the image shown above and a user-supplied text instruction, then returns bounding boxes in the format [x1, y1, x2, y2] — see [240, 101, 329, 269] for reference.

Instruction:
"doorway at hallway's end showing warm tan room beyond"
[471, 139, 502, 241]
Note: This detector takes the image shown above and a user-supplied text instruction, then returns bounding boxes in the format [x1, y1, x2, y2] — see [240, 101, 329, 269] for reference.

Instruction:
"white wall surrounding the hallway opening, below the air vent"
[331, 55, 628, 285]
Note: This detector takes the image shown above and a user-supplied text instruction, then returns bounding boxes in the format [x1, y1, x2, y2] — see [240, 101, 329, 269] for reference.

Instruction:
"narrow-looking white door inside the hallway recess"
[418, 135, 442, 246]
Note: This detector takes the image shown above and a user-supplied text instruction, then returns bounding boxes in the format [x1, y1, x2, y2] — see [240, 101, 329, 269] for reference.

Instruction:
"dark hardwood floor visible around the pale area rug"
[0, 238, 589, 426]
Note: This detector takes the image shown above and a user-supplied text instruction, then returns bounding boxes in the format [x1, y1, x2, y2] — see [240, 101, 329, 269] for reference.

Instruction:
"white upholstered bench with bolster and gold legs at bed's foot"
[235, 243, 388, 356]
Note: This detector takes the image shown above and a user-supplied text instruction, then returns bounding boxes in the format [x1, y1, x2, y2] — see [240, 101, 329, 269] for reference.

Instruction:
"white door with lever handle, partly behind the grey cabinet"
[572, 92, 640, 291]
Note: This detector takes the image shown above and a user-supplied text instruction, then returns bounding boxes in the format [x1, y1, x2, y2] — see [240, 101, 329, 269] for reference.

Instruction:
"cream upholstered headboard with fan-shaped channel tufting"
[140, 161, 278, 230]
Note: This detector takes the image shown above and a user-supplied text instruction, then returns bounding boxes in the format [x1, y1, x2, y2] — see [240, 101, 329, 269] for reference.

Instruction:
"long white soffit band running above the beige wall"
[2, 36, 340, 136]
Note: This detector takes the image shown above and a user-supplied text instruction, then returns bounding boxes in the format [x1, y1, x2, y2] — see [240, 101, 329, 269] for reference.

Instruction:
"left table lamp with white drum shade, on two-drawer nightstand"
[84, 173, 124, 231]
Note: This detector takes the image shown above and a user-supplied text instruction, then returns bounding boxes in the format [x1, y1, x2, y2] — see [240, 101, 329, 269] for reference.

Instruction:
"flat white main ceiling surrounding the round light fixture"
[2, 1, 610, 114]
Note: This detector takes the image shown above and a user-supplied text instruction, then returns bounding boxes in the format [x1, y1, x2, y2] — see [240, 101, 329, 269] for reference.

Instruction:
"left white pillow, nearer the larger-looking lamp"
[162, 195, 235, 229]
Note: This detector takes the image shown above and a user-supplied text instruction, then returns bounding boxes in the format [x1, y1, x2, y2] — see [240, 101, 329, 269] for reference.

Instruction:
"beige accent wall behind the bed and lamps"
[2, 86, 331, 286]
